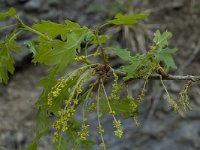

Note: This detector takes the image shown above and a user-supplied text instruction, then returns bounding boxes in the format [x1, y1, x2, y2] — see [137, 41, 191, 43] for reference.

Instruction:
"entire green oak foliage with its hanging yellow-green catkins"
[0, 8, 194, 150]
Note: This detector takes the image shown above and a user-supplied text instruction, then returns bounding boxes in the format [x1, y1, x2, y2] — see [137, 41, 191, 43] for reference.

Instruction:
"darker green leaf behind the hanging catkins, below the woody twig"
[100, 99, 135, 119]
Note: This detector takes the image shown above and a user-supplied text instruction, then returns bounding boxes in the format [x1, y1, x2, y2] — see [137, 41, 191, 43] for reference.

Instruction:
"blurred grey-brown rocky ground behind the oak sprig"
[0, 0, 200, 150]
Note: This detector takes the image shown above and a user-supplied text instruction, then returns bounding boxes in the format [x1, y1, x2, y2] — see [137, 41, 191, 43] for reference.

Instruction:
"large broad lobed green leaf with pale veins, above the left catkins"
[33, 37, 76, 65]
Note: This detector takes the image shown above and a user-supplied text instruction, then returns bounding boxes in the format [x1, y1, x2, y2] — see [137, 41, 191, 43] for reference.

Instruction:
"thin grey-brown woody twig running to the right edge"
[112, 70, 200, 82]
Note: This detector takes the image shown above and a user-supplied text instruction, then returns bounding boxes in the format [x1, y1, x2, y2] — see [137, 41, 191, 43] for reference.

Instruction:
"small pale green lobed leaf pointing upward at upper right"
[153, 30, 172, 50]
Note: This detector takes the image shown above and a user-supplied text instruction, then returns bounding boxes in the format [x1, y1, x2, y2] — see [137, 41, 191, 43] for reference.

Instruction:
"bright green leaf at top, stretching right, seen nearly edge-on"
[107, 13, 149, 25]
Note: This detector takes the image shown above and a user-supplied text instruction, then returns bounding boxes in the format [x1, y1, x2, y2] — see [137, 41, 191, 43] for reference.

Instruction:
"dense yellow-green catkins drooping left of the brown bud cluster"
[48, 67, 93, 142]
